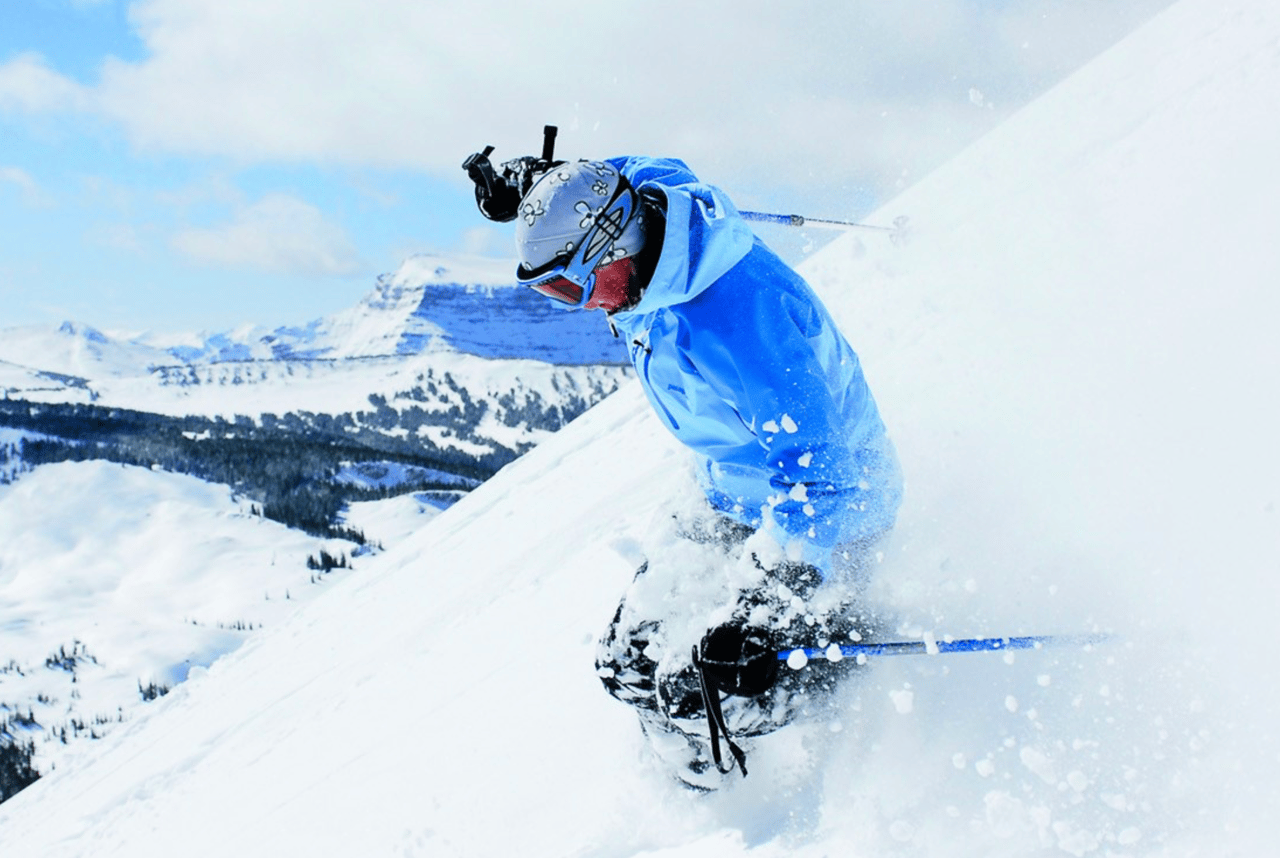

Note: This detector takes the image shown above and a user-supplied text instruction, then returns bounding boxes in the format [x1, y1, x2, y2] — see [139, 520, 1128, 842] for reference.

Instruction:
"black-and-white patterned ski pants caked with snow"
[596, 516, 868, 790]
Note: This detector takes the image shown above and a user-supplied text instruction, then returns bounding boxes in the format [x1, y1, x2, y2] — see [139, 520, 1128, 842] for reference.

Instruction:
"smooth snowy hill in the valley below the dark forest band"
[0, 463, 371, 778]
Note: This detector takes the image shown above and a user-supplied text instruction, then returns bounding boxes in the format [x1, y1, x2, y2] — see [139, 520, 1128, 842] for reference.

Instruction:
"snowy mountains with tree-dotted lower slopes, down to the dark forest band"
[0, 255, 627, 473]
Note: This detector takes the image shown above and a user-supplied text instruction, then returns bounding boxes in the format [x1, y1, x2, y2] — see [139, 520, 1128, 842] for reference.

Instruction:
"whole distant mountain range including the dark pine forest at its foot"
[0, 256, 628, 533]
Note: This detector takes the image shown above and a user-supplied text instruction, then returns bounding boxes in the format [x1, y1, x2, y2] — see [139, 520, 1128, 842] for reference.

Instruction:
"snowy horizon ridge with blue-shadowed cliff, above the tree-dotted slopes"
[0, 255, 626, 400]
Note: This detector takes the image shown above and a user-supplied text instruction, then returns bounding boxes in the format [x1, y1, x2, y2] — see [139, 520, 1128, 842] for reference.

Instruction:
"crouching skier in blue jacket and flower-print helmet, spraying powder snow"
[463, 140, 901, 790]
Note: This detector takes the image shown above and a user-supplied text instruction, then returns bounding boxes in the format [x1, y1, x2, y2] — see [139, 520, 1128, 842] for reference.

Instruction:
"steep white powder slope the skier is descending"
[0, 0, 1280, 858]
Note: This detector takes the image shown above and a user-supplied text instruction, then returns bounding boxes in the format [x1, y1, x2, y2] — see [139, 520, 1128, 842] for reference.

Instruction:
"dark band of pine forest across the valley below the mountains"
[0, 398, 537, 542]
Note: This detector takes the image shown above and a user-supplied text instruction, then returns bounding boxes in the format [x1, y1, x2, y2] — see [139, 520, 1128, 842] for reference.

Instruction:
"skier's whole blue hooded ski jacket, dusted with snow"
[609, 158, 902, 575]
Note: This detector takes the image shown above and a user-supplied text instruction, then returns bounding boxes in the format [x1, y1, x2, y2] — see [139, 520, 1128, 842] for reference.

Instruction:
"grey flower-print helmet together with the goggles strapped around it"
[516, 161, 644, 306]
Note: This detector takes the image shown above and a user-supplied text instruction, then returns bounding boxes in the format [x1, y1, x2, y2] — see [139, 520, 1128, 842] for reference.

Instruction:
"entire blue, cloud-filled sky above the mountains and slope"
[0, 0, 1169, 333]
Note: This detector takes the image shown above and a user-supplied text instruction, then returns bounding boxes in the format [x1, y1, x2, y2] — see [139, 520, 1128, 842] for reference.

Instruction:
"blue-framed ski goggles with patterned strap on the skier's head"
[516, 175, 639, 307]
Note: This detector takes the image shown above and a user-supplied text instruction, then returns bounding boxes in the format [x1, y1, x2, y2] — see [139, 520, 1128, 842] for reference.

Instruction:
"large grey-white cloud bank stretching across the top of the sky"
[0, 0, 1170, 215]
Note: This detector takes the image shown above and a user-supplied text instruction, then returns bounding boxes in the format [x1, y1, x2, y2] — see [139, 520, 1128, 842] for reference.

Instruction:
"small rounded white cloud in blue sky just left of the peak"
[170, 193, 364, 277]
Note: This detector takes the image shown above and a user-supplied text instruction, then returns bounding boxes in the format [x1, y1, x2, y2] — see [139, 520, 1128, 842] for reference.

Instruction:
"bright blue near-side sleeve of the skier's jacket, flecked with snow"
[689, 248, 883, 571]
